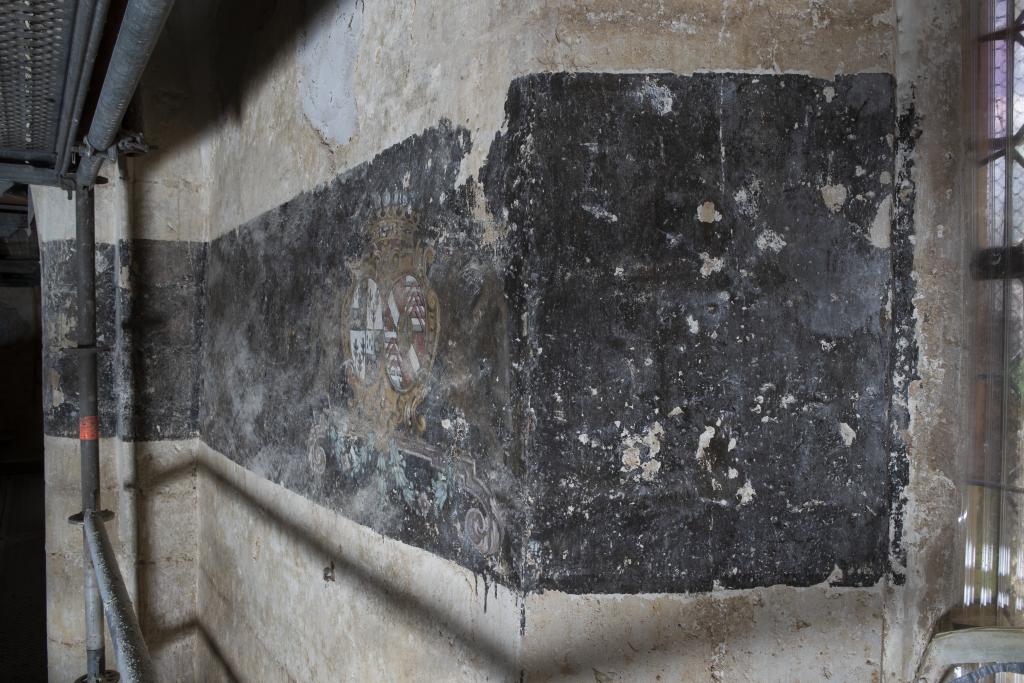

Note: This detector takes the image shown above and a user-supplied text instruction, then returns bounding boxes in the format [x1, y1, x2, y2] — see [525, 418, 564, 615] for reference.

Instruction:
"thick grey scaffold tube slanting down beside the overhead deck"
[78, 0, 174, 186]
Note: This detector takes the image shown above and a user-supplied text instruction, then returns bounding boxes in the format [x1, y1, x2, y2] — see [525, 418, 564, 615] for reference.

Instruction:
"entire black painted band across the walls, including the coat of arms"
[44, 68, 908, 592]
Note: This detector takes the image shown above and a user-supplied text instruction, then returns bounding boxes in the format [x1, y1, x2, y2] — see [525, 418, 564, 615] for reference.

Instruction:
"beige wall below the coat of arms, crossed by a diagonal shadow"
[194, 449, 522, 681]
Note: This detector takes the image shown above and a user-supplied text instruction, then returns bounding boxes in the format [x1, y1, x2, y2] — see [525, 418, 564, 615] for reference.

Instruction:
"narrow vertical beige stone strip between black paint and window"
[883, 0, 970, 681]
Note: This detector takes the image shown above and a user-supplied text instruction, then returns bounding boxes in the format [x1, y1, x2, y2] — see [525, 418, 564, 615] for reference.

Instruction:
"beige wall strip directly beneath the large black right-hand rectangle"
[523, 586, 882, 683]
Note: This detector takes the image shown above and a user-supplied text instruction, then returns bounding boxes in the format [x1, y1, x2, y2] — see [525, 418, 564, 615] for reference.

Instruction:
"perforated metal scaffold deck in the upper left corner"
[0, 0, 70, 158]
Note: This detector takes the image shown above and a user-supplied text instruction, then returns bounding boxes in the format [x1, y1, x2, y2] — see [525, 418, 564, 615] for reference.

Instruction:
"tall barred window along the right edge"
[952, 0, 1024, 651]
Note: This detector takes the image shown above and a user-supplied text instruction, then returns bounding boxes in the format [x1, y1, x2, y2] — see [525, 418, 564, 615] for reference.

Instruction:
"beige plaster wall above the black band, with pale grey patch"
[197, 0, 895, 238]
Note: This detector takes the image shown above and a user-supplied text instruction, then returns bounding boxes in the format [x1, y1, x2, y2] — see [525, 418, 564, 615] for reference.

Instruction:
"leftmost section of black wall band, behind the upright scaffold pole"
[42, 240, 206, 440]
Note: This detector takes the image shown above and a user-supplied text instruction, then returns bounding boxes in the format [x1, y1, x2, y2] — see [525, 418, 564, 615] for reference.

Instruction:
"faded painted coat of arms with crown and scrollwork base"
[308, 208, 502, 556]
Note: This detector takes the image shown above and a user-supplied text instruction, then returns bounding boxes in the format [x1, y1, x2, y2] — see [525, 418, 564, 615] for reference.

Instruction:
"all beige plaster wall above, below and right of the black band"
[37, 0, 961, 681]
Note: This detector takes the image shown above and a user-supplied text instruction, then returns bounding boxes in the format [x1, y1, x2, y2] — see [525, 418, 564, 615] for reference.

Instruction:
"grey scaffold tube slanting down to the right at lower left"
[83, 511, 157, 683]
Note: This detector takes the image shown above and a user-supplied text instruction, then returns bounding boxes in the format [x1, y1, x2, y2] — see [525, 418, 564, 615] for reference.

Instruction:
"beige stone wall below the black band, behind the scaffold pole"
[44, 437, 199, 680]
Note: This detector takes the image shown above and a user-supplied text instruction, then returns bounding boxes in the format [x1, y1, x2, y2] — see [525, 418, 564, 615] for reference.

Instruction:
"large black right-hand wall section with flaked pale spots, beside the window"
[487, 74, 894, 592]
